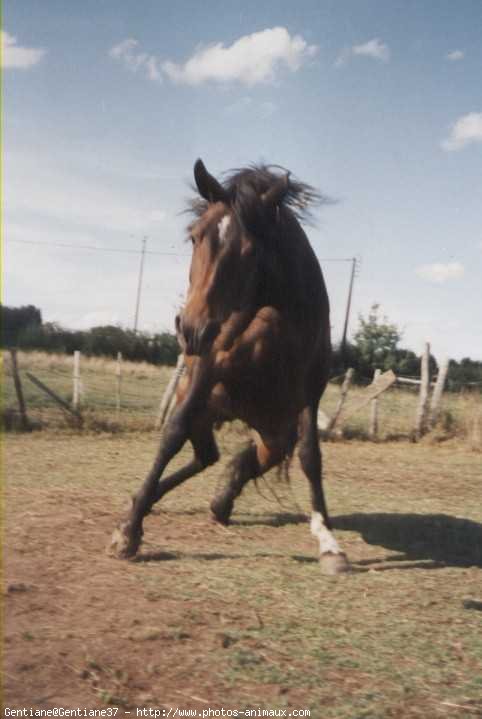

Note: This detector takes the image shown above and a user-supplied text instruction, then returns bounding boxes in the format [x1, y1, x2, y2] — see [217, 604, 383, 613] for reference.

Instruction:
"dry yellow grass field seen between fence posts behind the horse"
[4, 352, 482, 449]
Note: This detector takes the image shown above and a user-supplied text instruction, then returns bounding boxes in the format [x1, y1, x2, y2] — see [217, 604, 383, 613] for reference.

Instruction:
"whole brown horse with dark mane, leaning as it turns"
[112, 160, 349, 574]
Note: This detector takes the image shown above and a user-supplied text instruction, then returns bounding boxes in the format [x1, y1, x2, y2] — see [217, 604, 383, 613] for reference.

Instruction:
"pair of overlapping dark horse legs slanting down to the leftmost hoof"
[110, 410, 219, 558]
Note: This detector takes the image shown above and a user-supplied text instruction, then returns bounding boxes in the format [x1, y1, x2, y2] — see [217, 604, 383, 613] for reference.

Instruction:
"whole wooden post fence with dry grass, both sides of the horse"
[3, 352, 482, 445]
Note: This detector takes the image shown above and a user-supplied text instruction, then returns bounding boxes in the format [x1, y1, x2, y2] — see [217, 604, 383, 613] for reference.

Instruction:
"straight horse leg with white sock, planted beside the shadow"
[298, 407, 350, 574]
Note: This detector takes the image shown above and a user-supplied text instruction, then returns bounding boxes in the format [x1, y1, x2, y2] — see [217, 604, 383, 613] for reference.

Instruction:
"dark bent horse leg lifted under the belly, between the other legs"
[211, 437, 286, 524]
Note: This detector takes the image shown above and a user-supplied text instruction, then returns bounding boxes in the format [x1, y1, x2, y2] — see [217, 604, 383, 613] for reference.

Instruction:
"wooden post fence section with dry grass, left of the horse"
[3, 352, 172, 429]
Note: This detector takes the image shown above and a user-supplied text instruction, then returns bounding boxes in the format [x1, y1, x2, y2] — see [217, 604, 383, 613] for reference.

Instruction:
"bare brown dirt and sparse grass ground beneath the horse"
[3, 431, 482, 719]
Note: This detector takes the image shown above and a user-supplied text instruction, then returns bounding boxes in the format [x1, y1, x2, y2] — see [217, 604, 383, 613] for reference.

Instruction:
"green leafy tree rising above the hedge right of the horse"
[354, 304, 402, 374]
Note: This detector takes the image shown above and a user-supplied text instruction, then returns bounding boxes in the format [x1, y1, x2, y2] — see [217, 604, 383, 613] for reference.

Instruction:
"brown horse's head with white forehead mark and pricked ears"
[176, 160, 288, 355]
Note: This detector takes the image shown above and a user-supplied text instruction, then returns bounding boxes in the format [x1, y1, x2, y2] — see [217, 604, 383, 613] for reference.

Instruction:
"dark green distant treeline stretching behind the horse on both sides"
[0, 305, 482, 391]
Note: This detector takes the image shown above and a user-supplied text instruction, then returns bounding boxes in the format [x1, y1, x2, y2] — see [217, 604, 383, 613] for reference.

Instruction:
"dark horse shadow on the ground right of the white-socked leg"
[333, 513, 482, 567]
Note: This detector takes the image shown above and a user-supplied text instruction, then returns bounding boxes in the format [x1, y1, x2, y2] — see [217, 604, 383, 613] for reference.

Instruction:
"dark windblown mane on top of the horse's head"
[187, 165, 330, 224]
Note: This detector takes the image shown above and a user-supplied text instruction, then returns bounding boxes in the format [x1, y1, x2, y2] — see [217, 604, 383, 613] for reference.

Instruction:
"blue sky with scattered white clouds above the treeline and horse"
[2, 0, 482, 359]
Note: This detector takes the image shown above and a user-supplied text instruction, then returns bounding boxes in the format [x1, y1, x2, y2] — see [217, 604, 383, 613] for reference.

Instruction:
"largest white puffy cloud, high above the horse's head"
[162, 27, 318, 86]
